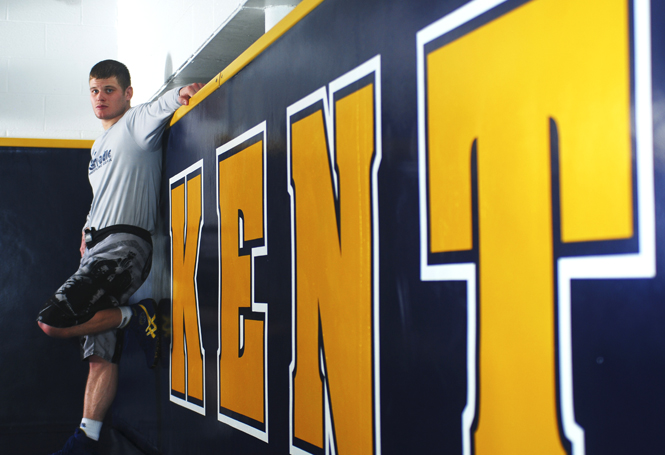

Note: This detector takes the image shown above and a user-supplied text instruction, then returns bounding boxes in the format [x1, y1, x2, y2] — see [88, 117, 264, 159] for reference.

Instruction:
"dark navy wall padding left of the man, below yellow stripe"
[0, 147, 91, 454]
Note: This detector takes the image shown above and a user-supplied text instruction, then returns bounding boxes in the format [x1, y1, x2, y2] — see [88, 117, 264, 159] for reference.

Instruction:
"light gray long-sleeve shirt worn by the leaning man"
[85, 87, 180, 233]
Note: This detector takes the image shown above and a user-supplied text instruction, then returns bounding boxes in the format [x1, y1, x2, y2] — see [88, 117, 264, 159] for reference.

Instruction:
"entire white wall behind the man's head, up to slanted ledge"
[0, 0, 253, 139]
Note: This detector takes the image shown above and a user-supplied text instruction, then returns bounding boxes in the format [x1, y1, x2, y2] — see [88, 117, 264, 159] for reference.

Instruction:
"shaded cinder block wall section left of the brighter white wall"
[0, 0, 118, 139]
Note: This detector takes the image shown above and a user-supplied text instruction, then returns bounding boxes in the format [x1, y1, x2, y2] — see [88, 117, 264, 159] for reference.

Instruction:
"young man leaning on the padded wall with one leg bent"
[37, 60, 202, 455]
